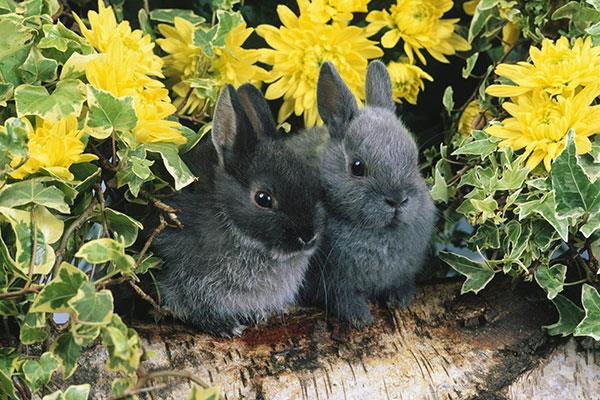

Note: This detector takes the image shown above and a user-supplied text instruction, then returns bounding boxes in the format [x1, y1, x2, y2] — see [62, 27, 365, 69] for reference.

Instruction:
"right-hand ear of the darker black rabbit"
[238, 83, 278, 140]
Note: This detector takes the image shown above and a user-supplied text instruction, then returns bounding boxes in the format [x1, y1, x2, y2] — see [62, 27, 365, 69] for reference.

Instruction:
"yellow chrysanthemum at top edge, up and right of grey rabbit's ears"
[367, 0, 471, 64]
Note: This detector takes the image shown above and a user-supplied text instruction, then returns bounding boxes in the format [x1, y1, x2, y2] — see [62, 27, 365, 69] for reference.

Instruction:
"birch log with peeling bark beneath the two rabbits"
[62, 282, 580, 400]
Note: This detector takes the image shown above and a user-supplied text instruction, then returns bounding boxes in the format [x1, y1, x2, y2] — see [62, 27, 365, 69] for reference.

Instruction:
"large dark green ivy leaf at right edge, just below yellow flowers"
[551, 130, 600, 217]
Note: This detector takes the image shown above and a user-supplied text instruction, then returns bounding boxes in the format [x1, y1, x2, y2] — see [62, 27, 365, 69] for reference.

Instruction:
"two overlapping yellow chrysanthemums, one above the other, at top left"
[74, 0, 186, 144]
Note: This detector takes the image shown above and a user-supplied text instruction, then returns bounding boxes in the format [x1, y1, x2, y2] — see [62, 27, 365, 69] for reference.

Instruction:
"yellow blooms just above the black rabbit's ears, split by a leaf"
[156, 17, 266, 114]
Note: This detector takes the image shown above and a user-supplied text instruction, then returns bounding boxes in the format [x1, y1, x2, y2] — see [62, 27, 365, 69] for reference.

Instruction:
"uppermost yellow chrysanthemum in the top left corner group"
[73, 0, 163, 79]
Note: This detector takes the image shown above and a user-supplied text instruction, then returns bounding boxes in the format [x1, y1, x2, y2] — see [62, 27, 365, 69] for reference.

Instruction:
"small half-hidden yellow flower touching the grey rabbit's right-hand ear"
[387, 62, 433, 104]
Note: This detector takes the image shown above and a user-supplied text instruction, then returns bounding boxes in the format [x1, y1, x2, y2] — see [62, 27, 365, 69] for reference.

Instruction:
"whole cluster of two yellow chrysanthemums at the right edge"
[486, 37, 600, 171]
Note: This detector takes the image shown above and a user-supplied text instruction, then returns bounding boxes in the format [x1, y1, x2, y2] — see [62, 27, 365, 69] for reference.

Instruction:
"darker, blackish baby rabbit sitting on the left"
[155, 84, 324, 337]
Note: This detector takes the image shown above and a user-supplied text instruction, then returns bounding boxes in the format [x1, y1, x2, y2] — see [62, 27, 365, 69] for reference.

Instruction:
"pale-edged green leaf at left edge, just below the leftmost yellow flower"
[0, 179, 70, 214]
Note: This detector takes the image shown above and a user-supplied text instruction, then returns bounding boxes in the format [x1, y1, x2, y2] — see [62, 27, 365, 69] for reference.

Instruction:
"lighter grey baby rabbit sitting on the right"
[301, 61, 435, 328]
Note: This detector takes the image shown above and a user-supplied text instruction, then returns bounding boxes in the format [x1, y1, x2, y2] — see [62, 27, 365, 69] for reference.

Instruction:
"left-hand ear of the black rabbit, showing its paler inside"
[212, 85, 256, 165]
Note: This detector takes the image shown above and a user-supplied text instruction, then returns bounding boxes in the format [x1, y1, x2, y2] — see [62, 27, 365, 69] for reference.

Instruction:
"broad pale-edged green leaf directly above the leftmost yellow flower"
[15, 79, 85, 121]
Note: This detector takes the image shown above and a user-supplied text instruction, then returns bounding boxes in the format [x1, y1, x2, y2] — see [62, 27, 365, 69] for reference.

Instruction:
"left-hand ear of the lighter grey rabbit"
[317, 61, 358, 139]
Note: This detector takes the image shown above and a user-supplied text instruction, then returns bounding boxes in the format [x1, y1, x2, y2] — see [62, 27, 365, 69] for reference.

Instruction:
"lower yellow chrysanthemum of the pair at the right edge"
[486, 86, 600, 171]
